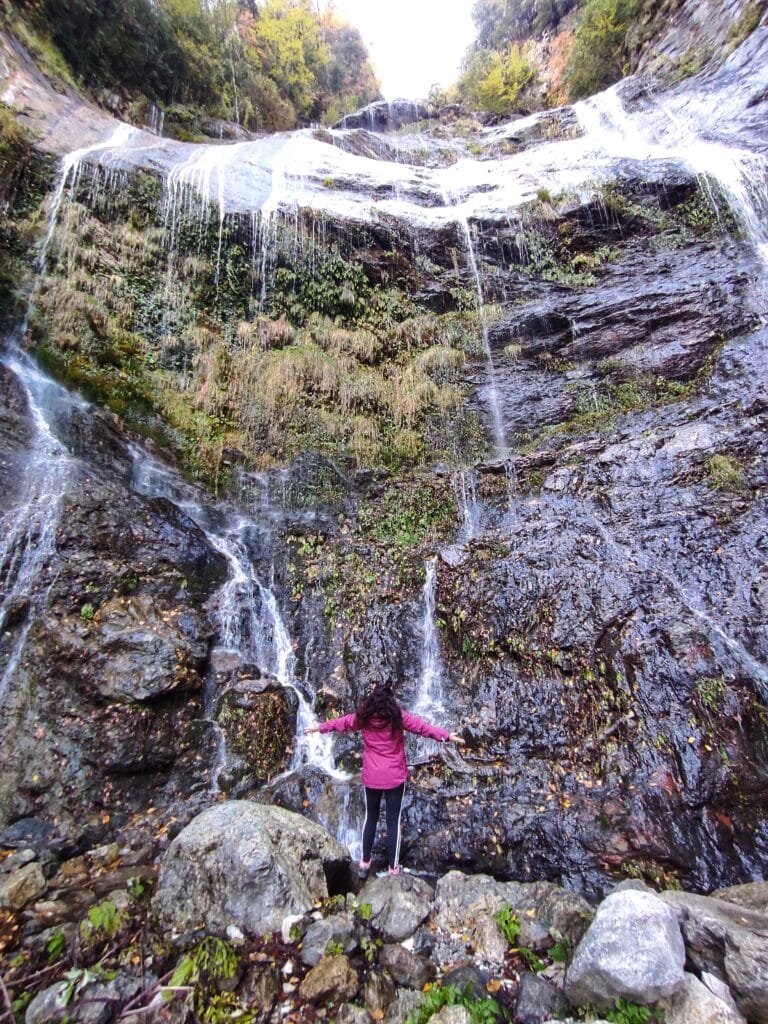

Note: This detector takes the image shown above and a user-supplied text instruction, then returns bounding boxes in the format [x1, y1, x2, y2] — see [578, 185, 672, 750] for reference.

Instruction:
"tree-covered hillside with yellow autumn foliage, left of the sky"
[0, 0, 379, 139]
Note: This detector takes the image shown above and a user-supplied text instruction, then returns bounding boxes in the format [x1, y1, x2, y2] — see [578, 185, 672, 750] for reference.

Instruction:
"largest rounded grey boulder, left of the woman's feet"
[153, 801, 349, 934]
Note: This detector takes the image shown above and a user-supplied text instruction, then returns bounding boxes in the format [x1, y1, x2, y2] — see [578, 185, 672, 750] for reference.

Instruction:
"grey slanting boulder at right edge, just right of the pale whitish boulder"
[663, 892, 768, 1024]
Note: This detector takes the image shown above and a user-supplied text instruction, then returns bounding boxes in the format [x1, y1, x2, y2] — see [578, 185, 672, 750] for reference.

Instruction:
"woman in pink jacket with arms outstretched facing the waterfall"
[305, 684, 464, 874]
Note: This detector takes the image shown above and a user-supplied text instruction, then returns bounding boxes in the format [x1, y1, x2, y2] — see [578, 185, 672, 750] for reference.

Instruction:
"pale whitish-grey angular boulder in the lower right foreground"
[565, 891, 685, 1009]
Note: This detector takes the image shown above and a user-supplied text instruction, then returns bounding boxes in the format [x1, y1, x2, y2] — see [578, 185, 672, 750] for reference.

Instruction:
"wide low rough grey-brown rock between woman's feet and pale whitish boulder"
[431, 871, 592, 963]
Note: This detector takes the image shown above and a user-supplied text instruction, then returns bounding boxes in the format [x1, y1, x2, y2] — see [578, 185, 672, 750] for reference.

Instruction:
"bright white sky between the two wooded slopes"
[333, 0, 475, 99]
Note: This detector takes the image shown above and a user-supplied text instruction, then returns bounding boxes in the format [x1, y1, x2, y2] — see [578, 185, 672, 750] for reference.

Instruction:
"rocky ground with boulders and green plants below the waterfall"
[0, 801, 768, 1024]
